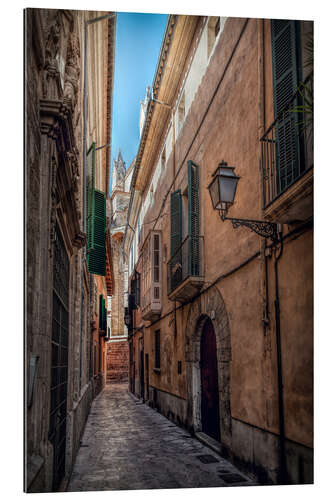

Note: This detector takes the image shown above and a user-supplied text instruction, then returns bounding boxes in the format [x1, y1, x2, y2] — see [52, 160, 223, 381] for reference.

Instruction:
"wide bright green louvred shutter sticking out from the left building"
[88, 189, 106, 276]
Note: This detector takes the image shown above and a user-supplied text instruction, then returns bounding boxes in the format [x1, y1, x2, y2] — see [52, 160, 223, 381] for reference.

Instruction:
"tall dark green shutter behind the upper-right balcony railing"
[271, 19, 299, 194]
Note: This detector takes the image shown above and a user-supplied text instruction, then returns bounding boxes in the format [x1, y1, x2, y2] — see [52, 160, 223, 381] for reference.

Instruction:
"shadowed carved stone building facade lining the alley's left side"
[25, 9, 115, 492]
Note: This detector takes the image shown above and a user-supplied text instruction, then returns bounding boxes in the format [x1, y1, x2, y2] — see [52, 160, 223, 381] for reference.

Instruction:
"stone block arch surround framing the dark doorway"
[185, 286, 231, 451]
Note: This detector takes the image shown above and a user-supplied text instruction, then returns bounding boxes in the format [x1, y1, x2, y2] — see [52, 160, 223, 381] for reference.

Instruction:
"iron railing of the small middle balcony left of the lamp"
[167, 236, 204, 294]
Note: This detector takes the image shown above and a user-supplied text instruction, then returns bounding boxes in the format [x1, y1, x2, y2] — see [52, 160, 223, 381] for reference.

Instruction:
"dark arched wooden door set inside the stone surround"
[200, 318, 221, 441]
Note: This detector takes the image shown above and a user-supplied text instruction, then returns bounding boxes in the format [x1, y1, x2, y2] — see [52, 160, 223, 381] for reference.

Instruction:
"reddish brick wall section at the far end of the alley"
[106, 340, 129, 383]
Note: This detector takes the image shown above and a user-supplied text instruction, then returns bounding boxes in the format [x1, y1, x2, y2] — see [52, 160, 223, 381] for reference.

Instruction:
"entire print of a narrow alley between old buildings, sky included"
[25, 8, 314, 494]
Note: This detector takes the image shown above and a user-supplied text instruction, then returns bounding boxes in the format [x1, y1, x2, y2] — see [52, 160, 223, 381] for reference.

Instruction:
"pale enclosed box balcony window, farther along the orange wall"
[141, 231, 162, 321]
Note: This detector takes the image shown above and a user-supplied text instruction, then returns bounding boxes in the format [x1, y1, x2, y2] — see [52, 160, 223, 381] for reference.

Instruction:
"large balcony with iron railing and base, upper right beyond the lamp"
[260, 74, 313, 224]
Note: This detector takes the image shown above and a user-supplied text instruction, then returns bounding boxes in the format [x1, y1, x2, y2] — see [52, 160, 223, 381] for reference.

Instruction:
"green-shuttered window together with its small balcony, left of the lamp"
[167, 161, 203, 301]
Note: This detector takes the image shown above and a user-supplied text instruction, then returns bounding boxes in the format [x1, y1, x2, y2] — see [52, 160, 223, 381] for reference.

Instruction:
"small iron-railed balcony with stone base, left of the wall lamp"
[167, 236, 204, 302]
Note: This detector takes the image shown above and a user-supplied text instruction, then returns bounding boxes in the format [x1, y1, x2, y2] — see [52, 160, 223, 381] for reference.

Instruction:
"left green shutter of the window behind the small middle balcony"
[170, 189, 183, 290]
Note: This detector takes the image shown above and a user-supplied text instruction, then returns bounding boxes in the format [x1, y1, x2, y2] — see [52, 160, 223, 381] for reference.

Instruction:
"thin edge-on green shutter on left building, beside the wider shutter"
[86, 142, 96, 253]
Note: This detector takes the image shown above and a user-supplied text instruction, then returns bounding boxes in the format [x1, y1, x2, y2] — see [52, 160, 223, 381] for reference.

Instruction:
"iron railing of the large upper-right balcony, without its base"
[260, 76, 313, 208]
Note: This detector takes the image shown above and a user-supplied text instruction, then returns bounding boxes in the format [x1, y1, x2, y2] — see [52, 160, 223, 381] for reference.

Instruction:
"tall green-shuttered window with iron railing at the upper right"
[261, 19, 313, 212]
